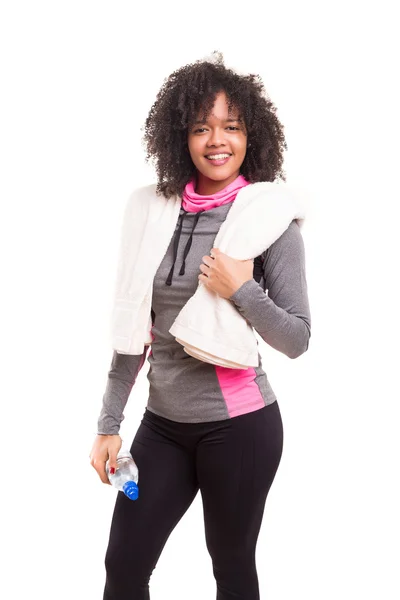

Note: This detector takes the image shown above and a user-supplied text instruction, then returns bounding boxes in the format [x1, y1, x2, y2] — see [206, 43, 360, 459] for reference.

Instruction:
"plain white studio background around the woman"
[0, 0, 400, 600]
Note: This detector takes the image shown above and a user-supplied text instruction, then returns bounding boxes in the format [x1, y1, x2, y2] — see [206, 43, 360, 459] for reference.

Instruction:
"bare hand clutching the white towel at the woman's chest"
[199, 248, 254, 299]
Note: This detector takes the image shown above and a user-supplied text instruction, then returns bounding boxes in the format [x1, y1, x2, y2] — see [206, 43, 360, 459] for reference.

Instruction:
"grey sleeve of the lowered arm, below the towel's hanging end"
[97, 346, 149, 435]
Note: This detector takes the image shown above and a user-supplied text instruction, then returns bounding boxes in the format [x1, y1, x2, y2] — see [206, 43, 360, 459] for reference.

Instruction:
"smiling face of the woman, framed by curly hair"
[188, 92, 247, 195]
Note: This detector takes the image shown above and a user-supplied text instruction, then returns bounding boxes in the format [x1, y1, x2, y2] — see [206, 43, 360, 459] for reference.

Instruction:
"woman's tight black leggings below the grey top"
[103, 401, 283, 600]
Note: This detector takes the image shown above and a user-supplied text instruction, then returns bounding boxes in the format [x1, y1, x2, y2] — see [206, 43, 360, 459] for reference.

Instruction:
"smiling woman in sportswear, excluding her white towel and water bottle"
[91, 54, 311, 600]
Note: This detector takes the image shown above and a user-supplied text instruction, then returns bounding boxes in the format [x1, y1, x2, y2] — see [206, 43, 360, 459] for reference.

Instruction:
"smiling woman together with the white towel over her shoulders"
[91, 48, 310, 600]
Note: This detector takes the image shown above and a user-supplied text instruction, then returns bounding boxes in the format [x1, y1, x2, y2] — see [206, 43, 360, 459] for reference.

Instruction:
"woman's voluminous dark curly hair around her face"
[142, 51, 287, 198]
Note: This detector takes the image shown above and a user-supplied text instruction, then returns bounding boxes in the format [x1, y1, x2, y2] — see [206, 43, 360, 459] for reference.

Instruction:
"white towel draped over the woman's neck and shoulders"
[111, 182, 305, 369]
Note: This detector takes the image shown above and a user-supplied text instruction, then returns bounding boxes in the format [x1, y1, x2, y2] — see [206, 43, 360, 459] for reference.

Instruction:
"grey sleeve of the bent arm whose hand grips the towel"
[229, 221, 311, 358]
